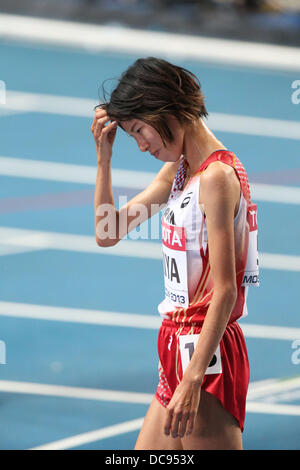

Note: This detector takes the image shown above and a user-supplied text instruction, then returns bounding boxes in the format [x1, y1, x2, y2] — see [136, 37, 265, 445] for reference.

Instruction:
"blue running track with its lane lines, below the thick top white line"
[0, 13, 300, 449]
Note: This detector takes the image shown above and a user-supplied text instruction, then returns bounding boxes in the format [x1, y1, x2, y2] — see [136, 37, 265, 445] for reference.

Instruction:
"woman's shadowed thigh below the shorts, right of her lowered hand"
[182, 390, 242, 450]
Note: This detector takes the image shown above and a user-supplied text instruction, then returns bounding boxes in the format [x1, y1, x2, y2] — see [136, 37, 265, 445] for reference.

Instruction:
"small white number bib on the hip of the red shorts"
[179, 334, 222, 375]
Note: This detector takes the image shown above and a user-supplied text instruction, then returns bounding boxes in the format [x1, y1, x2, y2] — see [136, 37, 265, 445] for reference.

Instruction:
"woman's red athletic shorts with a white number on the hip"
[155, 320, 249, 431]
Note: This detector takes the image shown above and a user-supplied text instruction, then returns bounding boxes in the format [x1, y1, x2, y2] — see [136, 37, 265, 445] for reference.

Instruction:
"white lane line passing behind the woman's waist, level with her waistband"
[0, 301, 300, 341]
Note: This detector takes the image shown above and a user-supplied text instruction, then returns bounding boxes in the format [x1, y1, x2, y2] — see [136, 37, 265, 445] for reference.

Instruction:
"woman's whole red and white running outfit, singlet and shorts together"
[156, 150, 259, 430]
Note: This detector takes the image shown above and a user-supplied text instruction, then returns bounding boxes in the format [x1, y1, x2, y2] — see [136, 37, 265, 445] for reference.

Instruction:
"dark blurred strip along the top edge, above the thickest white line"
[0, 0, 300, 45]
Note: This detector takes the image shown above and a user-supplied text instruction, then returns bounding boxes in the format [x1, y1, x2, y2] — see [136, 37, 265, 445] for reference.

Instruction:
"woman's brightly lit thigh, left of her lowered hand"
[135, 398, 182, 450]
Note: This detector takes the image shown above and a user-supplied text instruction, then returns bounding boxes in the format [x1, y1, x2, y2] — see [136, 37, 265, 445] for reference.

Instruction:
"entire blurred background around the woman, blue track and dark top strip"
[0, 0, 300, 449]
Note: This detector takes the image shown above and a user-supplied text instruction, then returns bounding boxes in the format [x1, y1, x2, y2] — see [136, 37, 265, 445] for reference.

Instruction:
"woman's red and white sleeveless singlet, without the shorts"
[158, 150, 259, 322]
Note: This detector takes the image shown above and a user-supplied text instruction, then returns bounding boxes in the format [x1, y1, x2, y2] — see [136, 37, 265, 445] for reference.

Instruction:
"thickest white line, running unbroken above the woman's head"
[0, 13, 300, 71]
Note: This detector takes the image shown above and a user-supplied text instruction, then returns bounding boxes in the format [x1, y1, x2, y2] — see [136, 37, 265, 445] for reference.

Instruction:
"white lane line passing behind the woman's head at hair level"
[0, 90, 300, 140]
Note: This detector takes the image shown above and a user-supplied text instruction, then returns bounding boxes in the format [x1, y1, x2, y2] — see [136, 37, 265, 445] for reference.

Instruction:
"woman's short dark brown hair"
[97, 57, 208, 142]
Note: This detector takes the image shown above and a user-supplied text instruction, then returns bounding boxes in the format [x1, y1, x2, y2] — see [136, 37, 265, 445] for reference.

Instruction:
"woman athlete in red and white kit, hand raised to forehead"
[91, 57, 259, 450]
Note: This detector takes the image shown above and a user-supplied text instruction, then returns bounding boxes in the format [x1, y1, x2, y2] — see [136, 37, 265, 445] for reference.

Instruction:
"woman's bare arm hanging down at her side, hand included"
[164, 162, 240, 437]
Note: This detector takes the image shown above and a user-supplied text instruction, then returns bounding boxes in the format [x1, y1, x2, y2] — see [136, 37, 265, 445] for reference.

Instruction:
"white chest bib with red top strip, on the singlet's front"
[162, 220, 189, 307]
